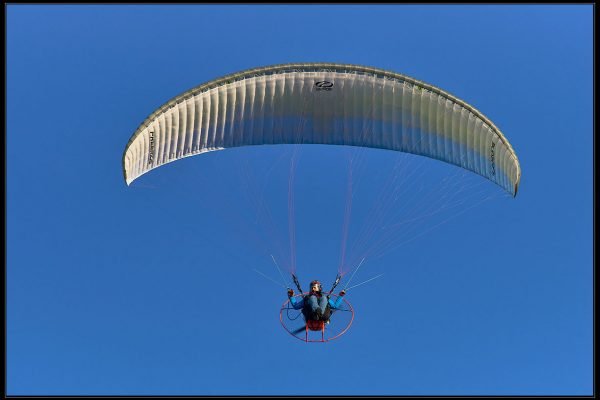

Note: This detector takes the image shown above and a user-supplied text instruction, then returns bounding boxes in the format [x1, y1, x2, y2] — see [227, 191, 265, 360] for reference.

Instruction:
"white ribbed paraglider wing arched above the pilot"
[123, 63, 521, 196]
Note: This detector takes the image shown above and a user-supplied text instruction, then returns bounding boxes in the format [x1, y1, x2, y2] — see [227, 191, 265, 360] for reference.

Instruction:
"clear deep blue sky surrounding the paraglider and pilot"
[6, 5, 593, 395]
